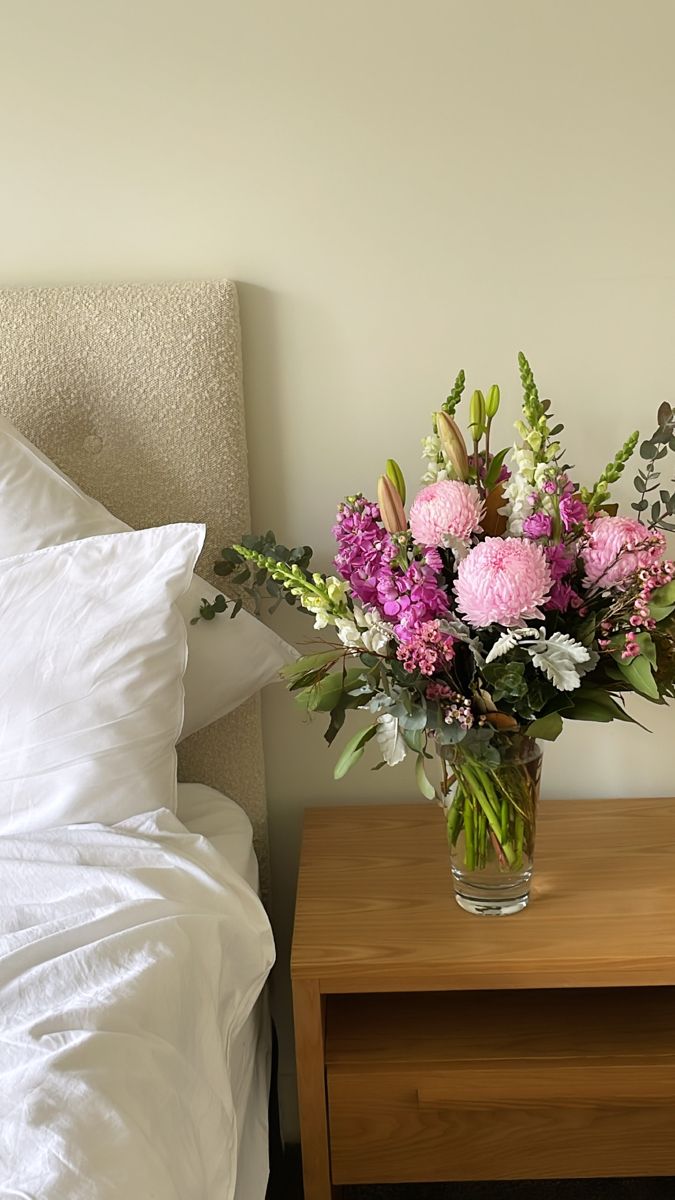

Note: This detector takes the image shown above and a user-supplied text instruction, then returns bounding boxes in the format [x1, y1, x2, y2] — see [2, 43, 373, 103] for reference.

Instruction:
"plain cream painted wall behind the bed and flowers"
[0, 0, 675, 1133]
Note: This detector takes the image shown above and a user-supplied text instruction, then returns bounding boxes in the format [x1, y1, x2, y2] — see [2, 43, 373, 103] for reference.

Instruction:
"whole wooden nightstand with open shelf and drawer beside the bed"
[292, 799, 675, 1200]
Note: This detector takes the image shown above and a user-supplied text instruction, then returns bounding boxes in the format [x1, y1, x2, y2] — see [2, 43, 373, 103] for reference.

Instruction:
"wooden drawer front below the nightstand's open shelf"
[328, 1061, 675, 1184]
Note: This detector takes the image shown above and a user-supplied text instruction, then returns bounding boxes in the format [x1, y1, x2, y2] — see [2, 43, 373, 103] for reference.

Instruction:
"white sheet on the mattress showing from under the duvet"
[178, 784, 271, 1200]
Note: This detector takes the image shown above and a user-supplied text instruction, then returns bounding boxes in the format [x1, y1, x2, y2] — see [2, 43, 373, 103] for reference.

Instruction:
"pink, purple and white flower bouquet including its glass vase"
[202, 354, 675, 914]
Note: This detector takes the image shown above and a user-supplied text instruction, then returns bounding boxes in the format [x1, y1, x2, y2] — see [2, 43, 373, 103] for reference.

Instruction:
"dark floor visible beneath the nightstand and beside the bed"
[269, 1146, 675, 1200]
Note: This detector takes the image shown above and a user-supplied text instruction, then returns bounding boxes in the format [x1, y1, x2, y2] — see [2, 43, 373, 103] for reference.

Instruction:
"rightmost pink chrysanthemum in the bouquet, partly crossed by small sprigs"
[581, 517, 665, 588]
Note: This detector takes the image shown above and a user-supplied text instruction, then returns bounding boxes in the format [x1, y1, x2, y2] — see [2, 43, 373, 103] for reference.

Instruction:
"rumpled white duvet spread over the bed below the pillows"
[0, 810, 274, 1200]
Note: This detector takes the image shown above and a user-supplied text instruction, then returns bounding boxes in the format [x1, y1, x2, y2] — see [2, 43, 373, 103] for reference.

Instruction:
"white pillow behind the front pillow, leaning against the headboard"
[0, 416, 297, 738]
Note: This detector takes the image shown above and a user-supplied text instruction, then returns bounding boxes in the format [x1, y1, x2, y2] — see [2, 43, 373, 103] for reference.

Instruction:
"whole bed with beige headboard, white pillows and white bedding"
[0, 281, 284, 1200]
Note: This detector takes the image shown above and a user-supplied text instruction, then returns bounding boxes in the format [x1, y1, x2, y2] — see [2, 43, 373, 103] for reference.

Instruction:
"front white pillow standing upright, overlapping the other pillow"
[0, 524, 204, 834]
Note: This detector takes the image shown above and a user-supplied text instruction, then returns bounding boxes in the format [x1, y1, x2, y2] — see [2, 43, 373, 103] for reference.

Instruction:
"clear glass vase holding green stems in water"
[446, 734, 542, 917]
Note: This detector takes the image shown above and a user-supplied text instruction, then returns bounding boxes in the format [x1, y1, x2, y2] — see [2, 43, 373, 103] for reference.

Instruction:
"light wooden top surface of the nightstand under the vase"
[291, 798, 675, 992]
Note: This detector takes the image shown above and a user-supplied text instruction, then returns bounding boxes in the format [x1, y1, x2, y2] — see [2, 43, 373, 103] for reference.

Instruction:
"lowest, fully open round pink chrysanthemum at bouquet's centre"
[455, 538, 552, 626]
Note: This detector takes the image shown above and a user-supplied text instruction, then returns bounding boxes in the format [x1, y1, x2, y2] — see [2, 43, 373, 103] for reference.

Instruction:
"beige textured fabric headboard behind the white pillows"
[0, 281, 268, 881]
